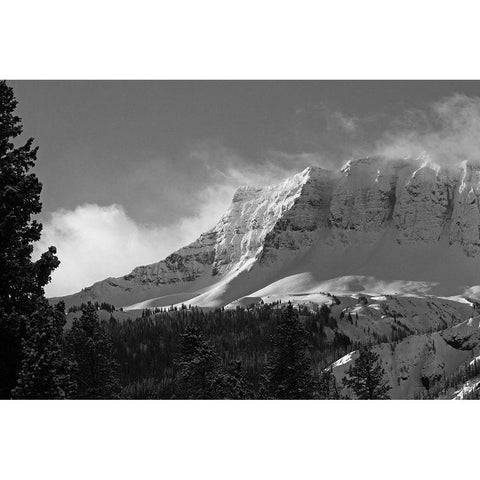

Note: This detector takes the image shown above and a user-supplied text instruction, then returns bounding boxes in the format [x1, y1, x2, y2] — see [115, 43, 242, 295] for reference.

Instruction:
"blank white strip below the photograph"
[0, 401, 479, 480]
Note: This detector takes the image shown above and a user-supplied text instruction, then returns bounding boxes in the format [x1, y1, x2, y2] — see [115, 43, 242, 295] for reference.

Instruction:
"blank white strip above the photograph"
[0, 0, 480, 79]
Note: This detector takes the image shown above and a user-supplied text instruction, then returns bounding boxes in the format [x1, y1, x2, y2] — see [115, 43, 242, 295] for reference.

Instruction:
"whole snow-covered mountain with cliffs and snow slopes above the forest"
[53, 157, 480, 309]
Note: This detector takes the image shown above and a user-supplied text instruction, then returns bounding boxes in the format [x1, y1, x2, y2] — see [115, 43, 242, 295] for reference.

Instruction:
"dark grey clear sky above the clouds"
[10, 81, 480, 222]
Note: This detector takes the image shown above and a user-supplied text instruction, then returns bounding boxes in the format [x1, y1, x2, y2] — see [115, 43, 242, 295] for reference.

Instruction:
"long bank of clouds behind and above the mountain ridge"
[35, 95, 480, 296]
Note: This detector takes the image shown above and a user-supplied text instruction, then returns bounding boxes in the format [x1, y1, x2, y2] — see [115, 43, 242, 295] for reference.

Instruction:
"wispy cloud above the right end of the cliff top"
[376, 94, 480, 166]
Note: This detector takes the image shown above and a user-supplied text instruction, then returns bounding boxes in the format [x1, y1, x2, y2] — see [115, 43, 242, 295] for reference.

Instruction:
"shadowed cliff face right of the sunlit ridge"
[267, 158, 480, 256]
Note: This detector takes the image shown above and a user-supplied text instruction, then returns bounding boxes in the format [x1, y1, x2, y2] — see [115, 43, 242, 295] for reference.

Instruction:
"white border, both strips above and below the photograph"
[0, 0, 480, 480]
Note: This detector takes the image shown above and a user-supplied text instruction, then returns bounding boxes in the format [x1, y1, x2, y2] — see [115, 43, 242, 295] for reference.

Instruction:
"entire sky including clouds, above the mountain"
[8, 81, 480, 294]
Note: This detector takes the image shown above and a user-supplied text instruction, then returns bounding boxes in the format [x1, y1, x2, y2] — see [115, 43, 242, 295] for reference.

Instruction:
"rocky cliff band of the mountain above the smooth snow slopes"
[55, 158, 480, 305]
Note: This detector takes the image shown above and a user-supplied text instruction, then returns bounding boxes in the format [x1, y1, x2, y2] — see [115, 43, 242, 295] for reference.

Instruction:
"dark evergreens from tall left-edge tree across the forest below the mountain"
[0, 82, 390, 399]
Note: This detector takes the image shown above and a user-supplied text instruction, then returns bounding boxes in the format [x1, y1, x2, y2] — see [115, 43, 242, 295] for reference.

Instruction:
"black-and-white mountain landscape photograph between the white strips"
[4, 81, 480, 400]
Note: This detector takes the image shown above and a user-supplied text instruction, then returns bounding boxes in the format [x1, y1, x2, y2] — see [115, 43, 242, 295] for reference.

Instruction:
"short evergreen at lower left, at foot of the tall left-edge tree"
[12, 300, 75, 399]
